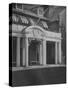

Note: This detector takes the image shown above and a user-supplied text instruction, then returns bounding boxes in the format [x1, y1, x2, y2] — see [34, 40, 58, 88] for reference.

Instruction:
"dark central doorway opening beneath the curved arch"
[29, 40, 40, 65]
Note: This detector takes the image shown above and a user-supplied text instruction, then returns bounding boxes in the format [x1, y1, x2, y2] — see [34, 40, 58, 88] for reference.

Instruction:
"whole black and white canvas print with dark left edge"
[9, 3, 66, 87]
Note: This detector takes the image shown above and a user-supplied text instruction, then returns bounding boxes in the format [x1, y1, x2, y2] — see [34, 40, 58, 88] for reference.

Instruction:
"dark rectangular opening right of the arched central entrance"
[46, 41, 55, 64]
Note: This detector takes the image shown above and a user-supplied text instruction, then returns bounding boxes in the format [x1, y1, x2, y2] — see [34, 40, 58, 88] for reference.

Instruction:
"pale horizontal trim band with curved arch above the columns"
[10, 25, 62, 40]
